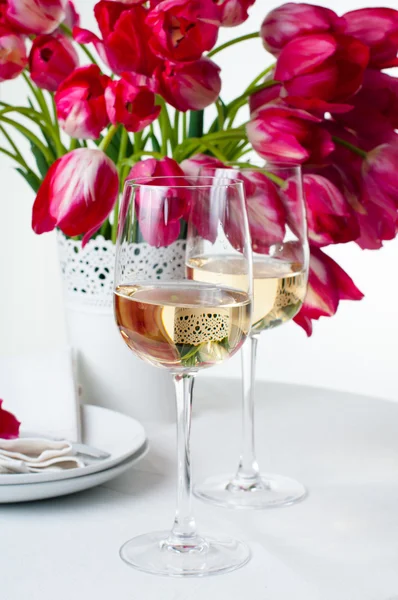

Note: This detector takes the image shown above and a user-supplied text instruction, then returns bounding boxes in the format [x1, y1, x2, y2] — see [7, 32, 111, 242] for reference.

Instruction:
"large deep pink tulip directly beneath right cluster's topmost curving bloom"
[274, 33, 369, 114]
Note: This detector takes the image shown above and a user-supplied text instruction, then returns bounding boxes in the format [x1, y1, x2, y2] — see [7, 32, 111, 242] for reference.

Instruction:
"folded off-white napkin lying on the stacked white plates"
[0, 438, 85, 473]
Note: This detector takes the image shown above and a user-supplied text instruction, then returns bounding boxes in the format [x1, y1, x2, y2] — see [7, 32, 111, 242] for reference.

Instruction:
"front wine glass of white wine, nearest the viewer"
[114, 176, 252, 577]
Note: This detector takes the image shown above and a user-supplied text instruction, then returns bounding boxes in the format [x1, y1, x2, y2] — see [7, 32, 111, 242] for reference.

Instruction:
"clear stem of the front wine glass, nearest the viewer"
[167, 374, 203, 550]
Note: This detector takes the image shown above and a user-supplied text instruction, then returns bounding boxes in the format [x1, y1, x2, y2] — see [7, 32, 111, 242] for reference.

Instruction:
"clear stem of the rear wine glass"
[236, 335, 259, 483]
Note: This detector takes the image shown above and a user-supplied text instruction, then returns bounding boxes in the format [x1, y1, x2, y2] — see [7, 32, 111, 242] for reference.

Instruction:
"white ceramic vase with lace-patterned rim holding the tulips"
[58, 233, 185, 421]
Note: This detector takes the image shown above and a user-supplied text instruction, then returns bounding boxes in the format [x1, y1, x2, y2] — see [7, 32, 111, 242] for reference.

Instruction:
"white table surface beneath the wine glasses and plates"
[0, 377, 398, 600]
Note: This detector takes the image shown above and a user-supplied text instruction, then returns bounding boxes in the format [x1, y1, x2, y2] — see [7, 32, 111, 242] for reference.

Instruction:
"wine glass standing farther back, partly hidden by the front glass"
[193, 164, 309, 509]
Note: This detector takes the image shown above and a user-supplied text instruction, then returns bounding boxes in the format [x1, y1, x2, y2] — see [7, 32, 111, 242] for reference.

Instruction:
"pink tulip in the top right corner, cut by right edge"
[344, 7, 398, 69]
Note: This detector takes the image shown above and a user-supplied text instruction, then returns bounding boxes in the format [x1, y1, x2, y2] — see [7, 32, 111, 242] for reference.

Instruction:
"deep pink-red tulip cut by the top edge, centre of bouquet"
[147, 0, 220, 62]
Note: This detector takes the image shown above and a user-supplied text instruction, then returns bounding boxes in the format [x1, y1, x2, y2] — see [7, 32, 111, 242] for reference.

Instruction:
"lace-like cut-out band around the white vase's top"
[58, 231, 186, 308]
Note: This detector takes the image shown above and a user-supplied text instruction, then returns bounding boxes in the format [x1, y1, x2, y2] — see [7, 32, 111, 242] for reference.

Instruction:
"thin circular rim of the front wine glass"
[124, 175, 243, 190]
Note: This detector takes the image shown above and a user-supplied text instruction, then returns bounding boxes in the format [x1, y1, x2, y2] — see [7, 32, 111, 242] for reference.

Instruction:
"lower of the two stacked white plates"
[0, 444, 148, 504]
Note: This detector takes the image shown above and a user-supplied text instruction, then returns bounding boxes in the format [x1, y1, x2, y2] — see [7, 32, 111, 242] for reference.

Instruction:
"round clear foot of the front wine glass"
[120, 531, 251, 577]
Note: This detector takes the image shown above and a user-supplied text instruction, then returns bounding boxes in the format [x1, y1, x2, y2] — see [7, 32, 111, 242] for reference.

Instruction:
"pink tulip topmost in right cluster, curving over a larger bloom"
[260, 2, 344, 56]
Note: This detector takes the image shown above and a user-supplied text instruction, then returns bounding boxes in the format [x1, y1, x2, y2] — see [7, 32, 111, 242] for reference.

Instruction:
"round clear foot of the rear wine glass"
[194, 474, 307, 509]
